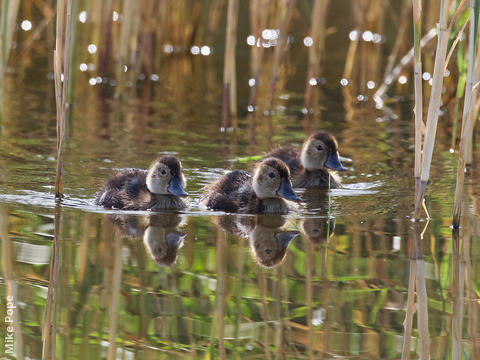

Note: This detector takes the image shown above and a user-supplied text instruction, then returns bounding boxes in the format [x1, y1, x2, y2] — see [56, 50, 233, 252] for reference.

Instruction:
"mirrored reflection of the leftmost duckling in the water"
[110, 214, 186, 266]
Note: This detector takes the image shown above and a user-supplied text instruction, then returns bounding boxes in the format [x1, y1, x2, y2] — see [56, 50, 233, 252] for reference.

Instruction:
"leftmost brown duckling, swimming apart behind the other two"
[95, 155, 188, 210]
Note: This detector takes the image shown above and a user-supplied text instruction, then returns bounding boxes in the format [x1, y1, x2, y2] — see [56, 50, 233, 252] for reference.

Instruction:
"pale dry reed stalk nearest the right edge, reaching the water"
[452, 0, 476, 228]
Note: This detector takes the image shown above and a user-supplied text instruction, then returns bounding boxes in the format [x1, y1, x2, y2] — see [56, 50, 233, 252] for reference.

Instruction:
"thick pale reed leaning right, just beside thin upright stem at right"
[415, 0, 449, 220]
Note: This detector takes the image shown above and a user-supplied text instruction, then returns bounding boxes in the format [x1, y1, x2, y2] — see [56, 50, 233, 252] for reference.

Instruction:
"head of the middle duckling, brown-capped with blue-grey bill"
[253, 158, 300, 201]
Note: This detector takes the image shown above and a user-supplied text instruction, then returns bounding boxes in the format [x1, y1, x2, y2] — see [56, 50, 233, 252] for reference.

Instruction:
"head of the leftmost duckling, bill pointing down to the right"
[147, 155, 188, 197]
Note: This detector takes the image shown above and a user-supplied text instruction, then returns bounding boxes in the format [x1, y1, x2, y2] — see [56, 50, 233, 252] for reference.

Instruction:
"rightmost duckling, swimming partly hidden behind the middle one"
[265, 131, 347, 188]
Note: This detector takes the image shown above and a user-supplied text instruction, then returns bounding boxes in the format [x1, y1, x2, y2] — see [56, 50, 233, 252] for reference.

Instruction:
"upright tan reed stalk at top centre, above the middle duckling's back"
[222, 0, 238, 129]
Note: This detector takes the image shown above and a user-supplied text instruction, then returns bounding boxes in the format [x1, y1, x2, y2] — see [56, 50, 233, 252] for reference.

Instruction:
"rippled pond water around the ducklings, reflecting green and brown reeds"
[0, 1, 480, 359]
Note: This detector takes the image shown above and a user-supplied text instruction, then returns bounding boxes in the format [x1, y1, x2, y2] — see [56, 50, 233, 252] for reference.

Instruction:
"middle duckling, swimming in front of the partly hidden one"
[201, 158, 300, 214]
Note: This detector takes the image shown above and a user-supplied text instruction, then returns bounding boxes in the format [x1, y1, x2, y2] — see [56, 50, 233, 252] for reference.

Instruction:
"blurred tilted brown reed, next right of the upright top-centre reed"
[267, 0, 295, 111]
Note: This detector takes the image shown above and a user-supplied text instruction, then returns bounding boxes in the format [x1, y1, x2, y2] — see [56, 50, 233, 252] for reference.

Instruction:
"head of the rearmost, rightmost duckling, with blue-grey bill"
[301, 131, 347, 171]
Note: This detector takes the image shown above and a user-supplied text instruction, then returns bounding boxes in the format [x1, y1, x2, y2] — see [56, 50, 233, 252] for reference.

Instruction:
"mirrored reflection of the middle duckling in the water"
[217, 214, 299, 268]
